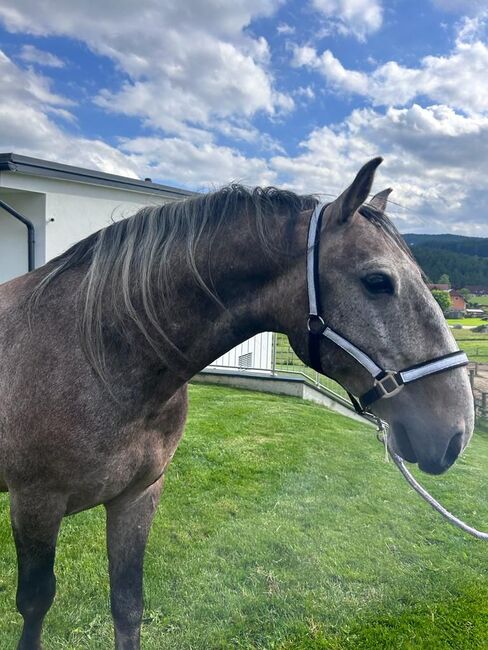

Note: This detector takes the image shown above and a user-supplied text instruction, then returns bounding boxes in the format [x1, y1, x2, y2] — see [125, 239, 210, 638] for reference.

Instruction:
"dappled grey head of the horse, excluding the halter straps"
[290, 159, 474, 474]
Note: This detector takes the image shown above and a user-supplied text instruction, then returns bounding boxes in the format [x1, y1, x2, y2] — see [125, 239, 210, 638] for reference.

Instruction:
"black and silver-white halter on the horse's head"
[307, 203, 468, 414]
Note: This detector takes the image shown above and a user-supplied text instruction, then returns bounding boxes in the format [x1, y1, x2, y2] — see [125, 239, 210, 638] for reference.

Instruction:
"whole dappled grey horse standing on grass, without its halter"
[0, 158, 474, 650]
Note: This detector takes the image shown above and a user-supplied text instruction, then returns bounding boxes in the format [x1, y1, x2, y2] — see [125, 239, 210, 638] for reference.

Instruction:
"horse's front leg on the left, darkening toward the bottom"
[10, 490, 66, 650]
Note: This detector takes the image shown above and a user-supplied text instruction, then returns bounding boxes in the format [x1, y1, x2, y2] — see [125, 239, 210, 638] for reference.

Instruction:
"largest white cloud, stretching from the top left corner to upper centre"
[0, 0, 294, 137]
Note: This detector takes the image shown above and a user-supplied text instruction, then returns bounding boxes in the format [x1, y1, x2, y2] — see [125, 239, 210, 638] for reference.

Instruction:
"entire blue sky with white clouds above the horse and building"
[0, 0, 488, 236]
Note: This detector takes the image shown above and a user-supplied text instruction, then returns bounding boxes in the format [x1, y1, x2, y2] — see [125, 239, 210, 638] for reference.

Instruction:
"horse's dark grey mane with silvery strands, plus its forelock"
[31, 184, 411, 385]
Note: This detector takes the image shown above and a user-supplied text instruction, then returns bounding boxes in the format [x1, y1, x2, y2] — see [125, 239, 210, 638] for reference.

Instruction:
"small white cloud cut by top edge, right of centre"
[312, 0, 383, 41]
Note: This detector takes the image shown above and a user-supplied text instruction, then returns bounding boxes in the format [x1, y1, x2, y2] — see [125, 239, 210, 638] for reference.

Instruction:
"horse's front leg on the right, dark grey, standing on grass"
[105, 477, 163, 650]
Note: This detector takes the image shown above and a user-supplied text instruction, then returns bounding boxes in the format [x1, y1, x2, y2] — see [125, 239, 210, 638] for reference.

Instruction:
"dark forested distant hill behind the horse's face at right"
[403, 233, 488, 289]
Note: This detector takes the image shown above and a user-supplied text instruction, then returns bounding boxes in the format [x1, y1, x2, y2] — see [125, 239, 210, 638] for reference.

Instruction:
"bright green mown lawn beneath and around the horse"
[0, 386, 488, 650]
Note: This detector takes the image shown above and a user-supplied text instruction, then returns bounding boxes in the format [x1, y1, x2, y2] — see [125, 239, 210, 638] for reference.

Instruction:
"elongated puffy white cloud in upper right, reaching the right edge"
[292, 19, 488, 113]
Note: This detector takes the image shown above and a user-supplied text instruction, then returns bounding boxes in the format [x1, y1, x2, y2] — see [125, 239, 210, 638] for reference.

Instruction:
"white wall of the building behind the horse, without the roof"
[0, 166, 272, 371]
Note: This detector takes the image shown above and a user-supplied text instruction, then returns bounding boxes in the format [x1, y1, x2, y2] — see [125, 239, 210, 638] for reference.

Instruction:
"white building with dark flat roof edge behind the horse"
[0, 153, 271, 370]
